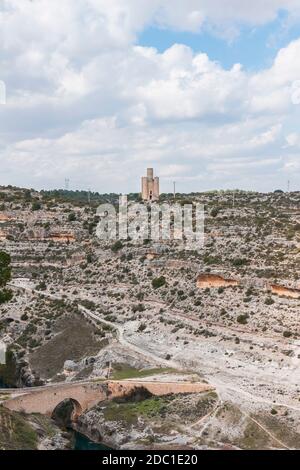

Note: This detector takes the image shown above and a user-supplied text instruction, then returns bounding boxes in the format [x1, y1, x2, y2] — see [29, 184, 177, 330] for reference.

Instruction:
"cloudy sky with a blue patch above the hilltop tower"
[0, 0, 300, 192]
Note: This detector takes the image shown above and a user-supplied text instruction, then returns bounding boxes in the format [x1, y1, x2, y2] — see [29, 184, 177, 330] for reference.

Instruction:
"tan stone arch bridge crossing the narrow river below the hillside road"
[3, 380, 213, 419]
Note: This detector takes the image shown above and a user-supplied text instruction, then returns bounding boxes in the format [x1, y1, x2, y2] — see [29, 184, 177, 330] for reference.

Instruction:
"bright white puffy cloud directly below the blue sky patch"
[132, 44, 245, 120]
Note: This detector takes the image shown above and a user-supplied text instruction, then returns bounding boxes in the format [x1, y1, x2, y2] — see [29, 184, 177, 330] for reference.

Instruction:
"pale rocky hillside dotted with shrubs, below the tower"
[0, 188, 300, 449]
